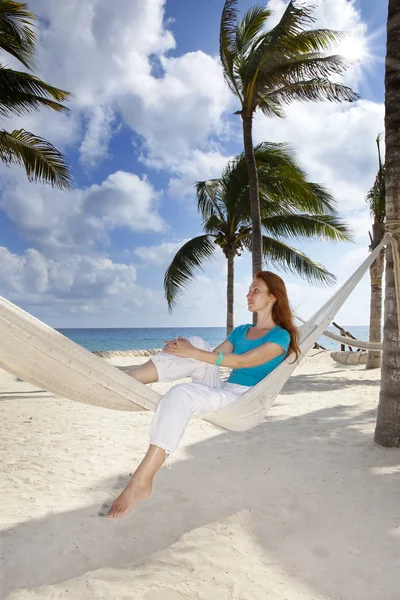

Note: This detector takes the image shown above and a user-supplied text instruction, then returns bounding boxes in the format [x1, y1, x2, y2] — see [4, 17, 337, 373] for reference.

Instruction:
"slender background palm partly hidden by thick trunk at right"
[365, 135, 386, 369]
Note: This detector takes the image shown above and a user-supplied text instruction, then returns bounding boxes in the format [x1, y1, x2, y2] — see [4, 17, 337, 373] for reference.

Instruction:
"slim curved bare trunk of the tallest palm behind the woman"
[242, 114, 262, 275]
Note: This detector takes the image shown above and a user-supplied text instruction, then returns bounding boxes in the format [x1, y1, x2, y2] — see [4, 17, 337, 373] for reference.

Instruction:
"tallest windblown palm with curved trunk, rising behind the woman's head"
[220, 0, 358, 273]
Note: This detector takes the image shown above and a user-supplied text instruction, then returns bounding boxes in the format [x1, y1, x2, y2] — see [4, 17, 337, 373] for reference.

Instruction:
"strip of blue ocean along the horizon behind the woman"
[58, 325, 369, 352]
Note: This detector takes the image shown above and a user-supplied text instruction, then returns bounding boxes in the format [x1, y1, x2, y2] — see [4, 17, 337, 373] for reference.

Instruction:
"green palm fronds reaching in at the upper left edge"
[0, 0, 71, 189]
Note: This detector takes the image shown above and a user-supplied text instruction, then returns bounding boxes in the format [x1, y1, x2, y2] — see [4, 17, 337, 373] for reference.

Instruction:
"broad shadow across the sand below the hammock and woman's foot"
[2, 400, 400, 600]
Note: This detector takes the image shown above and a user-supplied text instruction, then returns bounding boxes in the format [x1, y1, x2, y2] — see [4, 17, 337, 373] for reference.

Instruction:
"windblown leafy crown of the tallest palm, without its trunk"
[228, 0, 358, 117]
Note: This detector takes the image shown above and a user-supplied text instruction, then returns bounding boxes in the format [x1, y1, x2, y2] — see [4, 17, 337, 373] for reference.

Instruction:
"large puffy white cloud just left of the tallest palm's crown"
[117, 51, 233, 168]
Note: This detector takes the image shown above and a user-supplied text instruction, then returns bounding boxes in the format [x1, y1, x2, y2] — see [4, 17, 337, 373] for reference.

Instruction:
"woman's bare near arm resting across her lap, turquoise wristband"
[164, 338, 285, 369]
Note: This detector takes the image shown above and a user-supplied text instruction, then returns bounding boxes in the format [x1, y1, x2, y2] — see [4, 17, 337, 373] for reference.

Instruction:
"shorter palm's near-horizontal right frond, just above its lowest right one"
[261, 214, 353, 242]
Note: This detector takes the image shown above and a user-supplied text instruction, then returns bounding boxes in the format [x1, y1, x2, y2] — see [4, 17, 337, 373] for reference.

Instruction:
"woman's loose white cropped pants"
[150, 337, 249, 454]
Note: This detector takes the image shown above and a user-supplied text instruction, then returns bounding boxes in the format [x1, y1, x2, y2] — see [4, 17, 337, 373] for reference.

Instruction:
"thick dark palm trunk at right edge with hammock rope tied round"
[375, 0, 400, 447]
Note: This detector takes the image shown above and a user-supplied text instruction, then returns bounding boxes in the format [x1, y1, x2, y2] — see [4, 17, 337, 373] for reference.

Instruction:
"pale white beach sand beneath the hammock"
[0, 351, 400, 600]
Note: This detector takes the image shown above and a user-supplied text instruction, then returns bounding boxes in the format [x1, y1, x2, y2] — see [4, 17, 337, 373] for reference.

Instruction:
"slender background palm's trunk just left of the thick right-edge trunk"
[365, 220, 385, 369]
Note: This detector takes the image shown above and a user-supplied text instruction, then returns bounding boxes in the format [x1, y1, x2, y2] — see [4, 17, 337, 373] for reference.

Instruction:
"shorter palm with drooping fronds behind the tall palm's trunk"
[164, 142, 350, 333]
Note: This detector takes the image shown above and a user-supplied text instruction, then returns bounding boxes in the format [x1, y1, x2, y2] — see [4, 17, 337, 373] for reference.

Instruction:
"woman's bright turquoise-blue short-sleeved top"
[228, 323, 290, 386]
